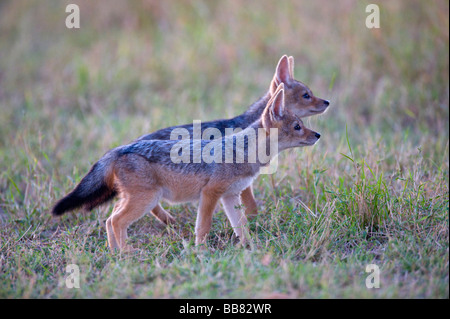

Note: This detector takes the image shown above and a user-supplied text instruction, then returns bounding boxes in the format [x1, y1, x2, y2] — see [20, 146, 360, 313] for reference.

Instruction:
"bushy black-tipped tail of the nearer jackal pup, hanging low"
[52, 155, 117, 216]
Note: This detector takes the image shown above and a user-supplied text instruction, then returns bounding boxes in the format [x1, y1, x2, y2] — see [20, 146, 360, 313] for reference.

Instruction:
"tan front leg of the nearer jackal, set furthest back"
[195, 190, 221, 246]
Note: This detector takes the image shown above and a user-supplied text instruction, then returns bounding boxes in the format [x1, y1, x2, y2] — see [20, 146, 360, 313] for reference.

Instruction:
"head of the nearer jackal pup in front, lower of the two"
[262, 83, 320, 151]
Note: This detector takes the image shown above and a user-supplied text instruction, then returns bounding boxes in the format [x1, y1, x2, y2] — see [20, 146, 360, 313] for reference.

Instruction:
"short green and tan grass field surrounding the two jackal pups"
[0, 0, 449, 298]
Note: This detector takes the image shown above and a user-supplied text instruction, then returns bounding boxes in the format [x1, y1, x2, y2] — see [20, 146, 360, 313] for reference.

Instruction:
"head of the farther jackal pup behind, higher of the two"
[270, 55, 330, 117]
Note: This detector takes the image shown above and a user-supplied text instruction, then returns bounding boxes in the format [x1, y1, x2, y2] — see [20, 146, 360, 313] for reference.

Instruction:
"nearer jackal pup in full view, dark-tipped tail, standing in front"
[52, 84, 320, 250]
